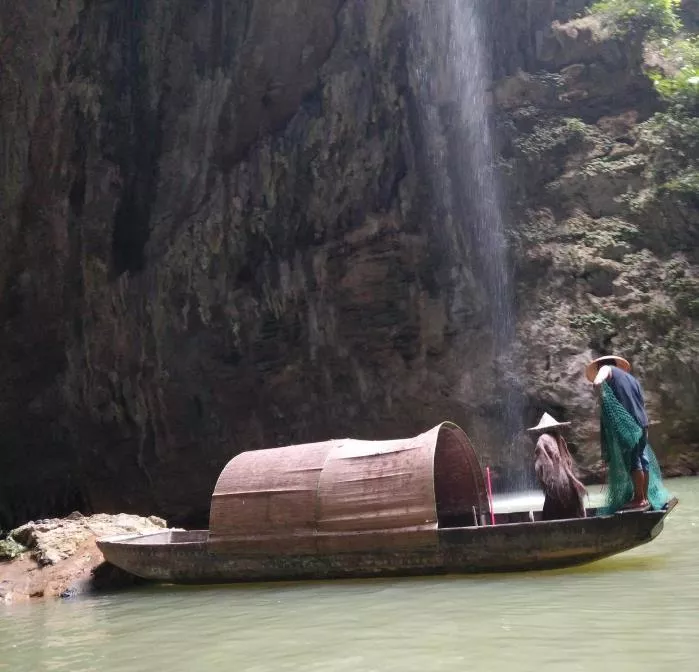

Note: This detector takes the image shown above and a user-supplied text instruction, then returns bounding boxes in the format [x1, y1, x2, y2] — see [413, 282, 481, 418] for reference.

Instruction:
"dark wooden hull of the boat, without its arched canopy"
[97, 511, 668, 584]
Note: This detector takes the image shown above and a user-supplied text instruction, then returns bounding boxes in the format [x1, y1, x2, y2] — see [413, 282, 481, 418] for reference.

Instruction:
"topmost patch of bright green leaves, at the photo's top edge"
[590, 0, 682, 36]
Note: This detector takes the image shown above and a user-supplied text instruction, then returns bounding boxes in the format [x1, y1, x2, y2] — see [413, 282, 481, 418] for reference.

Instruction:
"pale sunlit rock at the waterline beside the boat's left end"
[0, 512, 167, 602]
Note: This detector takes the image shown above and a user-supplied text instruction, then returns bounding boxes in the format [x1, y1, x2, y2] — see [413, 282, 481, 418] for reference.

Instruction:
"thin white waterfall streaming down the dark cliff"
[417, 0, 531, 489]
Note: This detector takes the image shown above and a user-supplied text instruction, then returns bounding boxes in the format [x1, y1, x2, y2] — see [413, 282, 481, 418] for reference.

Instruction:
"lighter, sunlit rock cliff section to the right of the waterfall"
[495, 5, 699, 473]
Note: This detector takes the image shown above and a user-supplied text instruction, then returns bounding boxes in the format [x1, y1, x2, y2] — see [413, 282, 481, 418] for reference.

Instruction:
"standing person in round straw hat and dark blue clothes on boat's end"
[585, 355, 650, 510]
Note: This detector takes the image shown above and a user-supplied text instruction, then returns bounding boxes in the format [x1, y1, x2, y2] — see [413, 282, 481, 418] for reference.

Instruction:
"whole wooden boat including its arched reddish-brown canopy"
[97, 423, 676, 584]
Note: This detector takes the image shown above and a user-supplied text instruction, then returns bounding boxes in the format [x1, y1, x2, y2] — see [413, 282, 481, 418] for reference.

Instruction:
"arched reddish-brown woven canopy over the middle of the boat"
[209, 423, 488, 555]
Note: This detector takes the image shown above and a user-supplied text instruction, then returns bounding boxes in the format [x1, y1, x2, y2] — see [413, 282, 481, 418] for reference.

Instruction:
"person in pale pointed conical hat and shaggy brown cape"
[527, 413, 586, 520]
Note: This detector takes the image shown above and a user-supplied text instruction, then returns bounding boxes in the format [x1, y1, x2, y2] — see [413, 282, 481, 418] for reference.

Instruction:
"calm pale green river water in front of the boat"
[0, 479, 699, 672]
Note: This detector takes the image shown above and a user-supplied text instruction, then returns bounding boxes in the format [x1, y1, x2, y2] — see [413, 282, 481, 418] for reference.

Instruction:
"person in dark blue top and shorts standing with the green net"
[585, 355, 650, 509]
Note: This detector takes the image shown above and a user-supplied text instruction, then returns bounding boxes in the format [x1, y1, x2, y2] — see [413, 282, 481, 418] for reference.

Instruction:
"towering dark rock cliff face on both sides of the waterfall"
[0, 0, 699, 526]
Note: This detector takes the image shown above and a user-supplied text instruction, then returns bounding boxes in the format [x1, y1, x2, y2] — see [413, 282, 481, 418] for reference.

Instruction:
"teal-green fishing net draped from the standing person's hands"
[601, 383, 671, 514]
